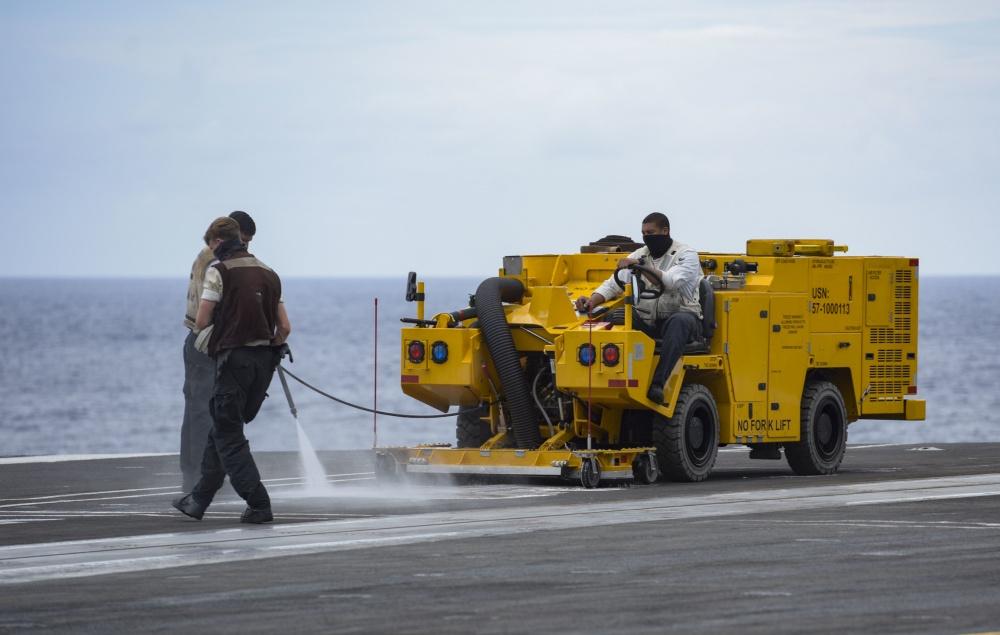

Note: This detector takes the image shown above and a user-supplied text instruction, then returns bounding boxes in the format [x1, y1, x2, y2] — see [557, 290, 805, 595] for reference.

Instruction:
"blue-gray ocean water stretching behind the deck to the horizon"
[0, 276, 1000, 455]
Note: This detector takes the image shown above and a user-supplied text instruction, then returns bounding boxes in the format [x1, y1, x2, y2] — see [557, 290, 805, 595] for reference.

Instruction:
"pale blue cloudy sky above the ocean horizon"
[0, 0, 1000, 278]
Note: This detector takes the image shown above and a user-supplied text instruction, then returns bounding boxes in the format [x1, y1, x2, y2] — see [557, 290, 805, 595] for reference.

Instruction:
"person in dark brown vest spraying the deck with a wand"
[173, 219, 291, 523]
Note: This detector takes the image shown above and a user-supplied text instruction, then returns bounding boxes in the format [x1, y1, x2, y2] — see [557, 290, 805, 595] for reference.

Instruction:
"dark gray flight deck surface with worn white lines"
[0, 444, 1000, 632]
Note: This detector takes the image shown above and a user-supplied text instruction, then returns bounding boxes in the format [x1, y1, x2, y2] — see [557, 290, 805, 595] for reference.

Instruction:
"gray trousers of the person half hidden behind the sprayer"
[181, 331, 215, 492]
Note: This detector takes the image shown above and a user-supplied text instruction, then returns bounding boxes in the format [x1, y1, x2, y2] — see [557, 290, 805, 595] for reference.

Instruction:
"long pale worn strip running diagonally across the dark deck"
[0, 473, 1000, 584]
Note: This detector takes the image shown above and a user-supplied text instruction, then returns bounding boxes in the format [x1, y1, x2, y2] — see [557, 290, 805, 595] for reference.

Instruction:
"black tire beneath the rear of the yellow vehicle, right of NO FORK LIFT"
[785, 381, 847, 476]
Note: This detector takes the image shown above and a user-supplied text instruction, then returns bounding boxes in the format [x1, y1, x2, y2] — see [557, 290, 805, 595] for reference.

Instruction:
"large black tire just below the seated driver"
[653, 384, 719, 483]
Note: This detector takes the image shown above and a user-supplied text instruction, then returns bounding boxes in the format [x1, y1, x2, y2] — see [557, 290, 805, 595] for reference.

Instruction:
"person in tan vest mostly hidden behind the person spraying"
[180, 211, 257, 492]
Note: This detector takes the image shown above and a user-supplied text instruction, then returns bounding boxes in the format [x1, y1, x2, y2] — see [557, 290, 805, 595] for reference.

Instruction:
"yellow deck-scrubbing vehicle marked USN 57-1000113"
[376, 236, 925, 488]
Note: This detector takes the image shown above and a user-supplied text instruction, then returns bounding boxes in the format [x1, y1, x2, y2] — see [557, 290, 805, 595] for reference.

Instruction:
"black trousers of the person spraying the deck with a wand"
[191, 346, 280, 508]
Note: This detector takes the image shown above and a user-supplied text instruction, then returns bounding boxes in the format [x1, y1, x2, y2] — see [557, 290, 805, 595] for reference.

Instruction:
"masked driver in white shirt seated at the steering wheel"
[576, 212, 702, 403]
